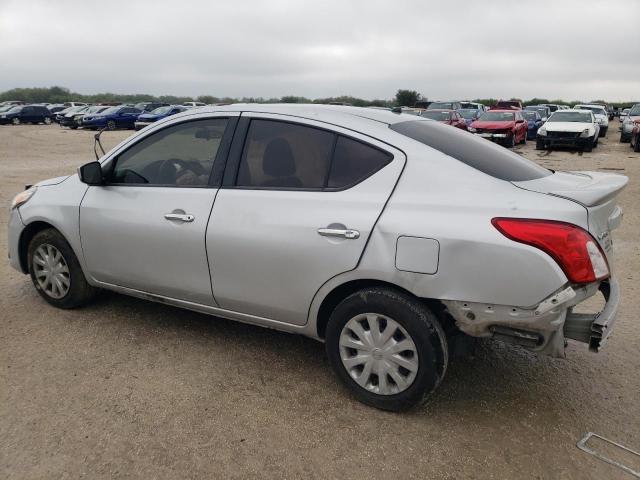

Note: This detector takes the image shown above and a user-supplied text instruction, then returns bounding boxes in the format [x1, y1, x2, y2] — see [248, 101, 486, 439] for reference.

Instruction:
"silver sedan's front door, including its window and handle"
[80, 114, 235, 305]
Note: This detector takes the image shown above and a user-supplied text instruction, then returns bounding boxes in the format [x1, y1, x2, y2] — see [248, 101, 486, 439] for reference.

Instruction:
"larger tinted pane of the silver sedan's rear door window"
[236, 120, 335, 189]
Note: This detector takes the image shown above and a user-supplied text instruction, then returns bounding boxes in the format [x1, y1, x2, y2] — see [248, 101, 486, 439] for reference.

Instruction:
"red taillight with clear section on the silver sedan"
[491, 218, 609, 283]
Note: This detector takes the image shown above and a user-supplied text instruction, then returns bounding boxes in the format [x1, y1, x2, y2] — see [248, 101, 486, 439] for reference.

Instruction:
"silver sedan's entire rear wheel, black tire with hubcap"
[325, 288, 449, 411]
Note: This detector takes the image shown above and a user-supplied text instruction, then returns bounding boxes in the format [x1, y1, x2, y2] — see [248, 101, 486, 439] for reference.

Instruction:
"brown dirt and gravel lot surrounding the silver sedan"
[0, 120, 640, 479]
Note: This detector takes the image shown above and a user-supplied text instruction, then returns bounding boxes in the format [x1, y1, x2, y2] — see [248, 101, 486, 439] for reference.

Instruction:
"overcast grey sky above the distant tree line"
[0, 0, 640, 101]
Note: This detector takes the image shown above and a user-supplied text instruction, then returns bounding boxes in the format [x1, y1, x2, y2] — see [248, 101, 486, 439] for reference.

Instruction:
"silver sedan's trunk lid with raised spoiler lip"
[513, 172, 629, 256]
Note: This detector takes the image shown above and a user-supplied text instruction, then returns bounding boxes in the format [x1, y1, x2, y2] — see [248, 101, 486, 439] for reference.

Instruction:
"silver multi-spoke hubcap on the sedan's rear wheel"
[340, 313, 418, 395]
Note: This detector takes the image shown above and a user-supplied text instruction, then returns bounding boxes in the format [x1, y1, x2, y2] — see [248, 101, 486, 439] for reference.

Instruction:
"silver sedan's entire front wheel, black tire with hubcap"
[27, 228, 97, 309]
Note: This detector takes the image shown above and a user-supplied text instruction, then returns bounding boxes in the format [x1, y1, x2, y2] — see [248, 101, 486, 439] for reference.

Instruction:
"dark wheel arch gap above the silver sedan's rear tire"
[315, 278, 444, 339]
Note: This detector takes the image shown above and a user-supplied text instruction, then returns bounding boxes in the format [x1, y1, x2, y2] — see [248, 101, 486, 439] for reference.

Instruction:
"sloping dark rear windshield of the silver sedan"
[389, 120, 551, 182]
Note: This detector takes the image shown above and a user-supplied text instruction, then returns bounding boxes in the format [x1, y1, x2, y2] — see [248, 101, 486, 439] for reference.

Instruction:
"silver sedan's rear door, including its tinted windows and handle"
[207, 113, 405, 325]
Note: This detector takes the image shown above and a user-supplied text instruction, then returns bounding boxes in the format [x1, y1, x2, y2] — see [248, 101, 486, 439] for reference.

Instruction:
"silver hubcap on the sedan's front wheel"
[33, 243, 71, 299]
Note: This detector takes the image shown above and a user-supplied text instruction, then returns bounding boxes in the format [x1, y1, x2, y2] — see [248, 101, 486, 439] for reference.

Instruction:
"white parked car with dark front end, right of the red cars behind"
[536, 109, 600, 152]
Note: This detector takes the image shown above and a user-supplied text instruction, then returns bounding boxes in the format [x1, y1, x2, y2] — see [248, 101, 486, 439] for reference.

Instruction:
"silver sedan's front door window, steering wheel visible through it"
[111, 118, 228, 187]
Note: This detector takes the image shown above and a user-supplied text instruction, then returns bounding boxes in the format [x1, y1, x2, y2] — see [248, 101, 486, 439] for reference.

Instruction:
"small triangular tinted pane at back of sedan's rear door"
[327, 136, 393, 188]
